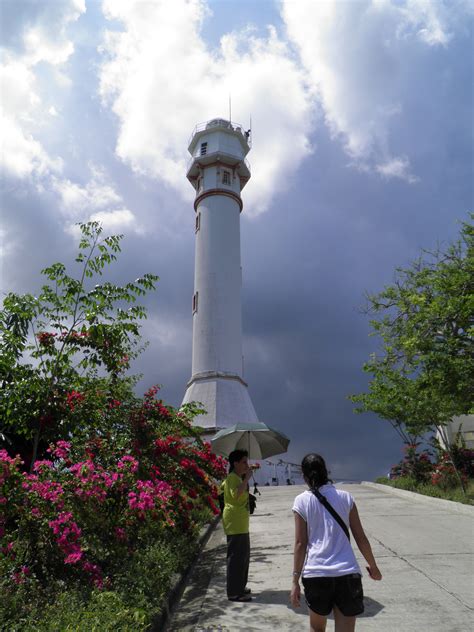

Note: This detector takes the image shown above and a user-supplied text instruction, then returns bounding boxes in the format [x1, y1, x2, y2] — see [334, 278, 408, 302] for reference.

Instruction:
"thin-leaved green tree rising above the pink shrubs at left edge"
[0, 222, 158, 467]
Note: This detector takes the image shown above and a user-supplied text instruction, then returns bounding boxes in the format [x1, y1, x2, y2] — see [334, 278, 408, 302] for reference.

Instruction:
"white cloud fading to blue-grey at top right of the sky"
[282, 0, 472, 183]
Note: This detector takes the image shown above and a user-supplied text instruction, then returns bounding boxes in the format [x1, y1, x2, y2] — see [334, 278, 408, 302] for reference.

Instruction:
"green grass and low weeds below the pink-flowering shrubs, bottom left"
[0, 533, 206, 632]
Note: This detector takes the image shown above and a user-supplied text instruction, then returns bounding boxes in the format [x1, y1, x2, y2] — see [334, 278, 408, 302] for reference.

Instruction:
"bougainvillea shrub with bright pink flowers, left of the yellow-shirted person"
[0, 388, 225, 628]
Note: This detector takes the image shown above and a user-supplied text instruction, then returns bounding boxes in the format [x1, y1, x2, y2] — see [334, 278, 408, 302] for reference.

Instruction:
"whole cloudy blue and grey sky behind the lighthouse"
[0, 0, 474, 480]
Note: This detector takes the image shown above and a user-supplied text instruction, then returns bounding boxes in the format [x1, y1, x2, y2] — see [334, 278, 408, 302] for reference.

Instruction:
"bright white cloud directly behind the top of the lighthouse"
[100, 0, 314, 214]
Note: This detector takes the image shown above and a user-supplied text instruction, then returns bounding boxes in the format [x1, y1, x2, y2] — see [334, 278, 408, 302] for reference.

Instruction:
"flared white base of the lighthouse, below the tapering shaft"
[183, 372, 258, 433]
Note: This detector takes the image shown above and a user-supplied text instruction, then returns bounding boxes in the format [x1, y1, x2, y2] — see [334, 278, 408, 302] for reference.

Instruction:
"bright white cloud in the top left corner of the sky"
[0, 0, 85, 178]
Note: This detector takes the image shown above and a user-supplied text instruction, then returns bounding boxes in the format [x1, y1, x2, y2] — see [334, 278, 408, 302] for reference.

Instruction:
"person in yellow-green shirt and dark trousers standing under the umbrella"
[222, 450, 252, 601]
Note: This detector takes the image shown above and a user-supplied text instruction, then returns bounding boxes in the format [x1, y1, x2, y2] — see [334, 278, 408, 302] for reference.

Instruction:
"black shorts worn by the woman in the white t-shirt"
[302, 573, 364, 617]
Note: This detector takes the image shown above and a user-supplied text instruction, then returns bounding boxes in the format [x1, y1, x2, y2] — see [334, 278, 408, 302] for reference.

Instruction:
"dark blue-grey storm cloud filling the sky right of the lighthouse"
[235, 97, 472, 479]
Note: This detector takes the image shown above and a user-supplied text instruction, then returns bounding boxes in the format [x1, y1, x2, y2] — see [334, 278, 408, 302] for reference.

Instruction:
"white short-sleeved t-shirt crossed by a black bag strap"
[293, 484, 360, 577]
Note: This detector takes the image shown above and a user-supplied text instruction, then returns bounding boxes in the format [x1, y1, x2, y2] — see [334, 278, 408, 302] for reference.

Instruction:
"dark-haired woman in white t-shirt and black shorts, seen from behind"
[291, 454, 382, 632]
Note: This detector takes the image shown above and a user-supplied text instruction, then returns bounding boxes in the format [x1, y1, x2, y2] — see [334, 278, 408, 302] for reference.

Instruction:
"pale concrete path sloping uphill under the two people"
[168, 484, 474, 632]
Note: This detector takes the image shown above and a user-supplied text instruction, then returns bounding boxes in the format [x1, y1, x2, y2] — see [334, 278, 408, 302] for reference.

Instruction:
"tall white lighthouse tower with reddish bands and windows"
[183, 119, 258, 434]
